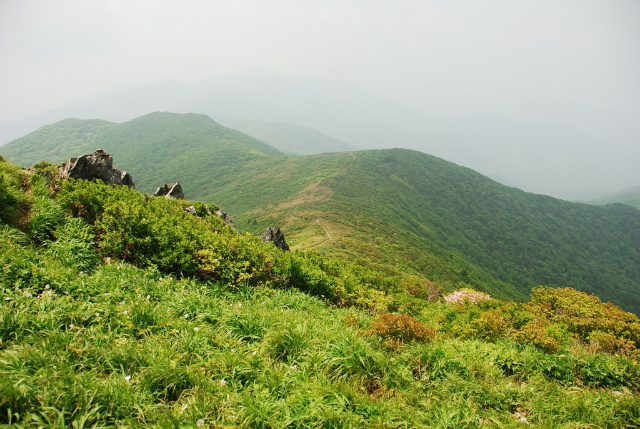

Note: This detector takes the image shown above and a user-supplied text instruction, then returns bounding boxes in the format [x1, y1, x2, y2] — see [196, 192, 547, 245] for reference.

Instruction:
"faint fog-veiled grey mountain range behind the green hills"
[0, 69, 640, 200]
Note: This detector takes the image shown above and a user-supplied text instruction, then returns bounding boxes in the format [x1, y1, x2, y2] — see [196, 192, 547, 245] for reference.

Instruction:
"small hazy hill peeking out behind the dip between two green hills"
[230, 120, 357, 155]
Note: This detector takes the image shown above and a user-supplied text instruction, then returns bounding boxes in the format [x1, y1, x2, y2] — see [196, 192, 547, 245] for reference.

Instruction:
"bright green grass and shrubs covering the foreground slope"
[0, 156, 640, 428]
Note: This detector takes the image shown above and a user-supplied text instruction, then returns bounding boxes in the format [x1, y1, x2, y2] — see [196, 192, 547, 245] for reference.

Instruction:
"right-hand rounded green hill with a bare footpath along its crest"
[206, 150, 640, 312]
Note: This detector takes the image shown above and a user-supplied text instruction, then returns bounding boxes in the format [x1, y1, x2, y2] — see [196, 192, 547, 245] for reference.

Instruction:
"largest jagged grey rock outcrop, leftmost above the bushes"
[60, 149, 136, 189]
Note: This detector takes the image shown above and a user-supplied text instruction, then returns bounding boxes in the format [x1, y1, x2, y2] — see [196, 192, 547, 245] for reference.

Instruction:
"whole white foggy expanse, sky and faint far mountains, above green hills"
[0, 0, 640, 199]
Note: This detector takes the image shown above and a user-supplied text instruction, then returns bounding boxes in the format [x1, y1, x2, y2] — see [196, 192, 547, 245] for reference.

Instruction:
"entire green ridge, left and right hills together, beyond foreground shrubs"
[0, 113, 640, 313]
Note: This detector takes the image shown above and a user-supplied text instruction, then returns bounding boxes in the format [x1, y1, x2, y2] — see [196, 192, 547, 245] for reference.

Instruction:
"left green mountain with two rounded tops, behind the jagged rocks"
[0, 112, 279, 196]
